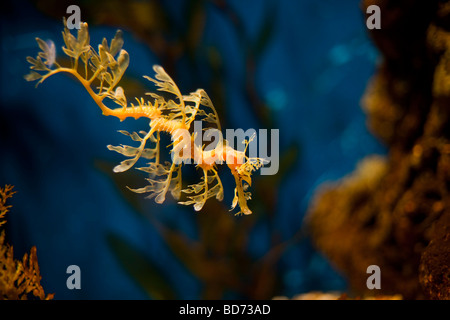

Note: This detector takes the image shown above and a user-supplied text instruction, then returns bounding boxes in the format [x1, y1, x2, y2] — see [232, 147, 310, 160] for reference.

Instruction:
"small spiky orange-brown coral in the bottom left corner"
[0, 185, 53, 300]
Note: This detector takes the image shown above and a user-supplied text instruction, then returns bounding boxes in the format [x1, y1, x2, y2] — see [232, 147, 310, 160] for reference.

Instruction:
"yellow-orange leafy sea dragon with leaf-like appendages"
[25, 20, 265, 215]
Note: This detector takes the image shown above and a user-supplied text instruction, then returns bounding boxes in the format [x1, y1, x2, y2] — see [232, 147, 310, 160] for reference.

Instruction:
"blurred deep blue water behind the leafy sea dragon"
[0, 0, 384, 299]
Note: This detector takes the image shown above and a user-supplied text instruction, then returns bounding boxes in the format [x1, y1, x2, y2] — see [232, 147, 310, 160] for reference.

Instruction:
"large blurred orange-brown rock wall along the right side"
[306, 0, 450, 299]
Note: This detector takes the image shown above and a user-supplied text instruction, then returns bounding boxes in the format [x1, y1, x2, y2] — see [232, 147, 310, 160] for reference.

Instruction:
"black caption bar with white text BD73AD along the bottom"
[0, 300, 450, 320]
